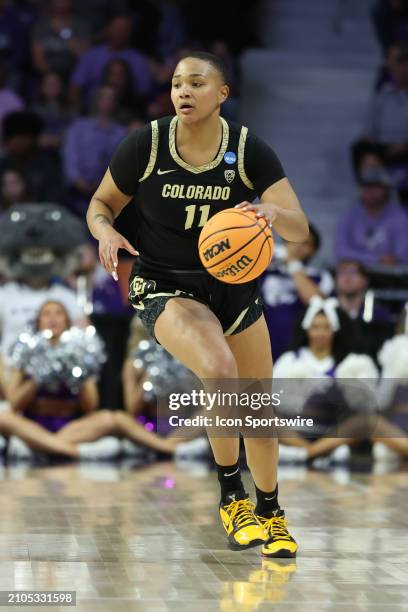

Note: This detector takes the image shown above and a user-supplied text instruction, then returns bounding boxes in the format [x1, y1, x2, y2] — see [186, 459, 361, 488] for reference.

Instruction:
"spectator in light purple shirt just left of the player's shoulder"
[62, 86, 126, 215]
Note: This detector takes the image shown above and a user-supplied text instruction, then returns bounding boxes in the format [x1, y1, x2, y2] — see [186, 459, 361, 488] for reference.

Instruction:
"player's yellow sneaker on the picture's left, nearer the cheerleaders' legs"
[220, 491, 268, 550]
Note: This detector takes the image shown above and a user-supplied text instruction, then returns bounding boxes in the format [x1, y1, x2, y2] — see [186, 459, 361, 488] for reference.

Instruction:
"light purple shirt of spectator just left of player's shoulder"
[63, 117, 126, 184]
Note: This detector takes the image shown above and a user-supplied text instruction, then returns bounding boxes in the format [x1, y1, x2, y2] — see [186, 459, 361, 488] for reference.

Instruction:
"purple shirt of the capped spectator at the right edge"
[335, 203, 408, 266]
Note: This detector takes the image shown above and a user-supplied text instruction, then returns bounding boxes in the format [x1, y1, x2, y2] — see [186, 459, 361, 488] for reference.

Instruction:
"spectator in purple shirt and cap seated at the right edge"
[335, 168, 408, 267]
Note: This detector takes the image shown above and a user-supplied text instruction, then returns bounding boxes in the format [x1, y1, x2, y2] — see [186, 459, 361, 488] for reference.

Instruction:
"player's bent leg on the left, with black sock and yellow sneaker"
[155, 298, 266, 550]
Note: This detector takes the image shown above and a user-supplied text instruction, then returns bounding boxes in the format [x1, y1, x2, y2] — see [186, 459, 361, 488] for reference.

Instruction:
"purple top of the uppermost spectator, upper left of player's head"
[71, 45, 152, 101]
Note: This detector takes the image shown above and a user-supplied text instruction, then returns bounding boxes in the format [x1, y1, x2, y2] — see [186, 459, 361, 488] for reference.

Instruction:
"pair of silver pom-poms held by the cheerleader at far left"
[10, 325, 106, 392]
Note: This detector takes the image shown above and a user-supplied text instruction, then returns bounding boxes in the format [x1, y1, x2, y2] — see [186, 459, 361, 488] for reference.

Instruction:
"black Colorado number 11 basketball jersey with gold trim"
[109, 117, 285, 268]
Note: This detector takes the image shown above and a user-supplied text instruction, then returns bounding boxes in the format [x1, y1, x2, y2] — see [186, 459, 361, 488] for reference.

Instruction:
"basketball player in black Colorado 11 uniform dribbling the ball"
[87, 52, 308, 557]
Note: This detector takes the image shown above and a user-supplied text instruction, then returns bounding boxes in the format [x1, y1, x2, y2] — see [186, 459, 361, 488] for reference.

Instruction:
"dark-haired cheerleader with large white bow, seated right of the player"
[274, 296, 378, 458]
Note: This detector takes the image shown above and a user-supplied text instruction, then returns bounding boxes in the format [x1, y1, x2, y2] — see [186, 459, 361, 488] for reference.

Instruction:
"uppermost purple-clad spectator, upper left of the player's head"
[71, 17, 152, 111]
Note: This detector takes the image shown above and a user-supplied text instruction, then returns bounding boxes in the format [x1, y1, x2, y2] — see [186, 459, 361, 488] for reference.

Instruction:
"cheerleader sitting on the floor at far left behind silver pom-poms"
[0, 301, 181, 459]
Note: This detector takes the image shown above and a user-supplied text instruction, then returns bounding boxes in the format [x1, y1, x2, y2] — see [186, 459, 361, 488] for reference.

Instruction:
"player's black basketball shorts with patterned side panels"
[129, 257, 263, 338]
